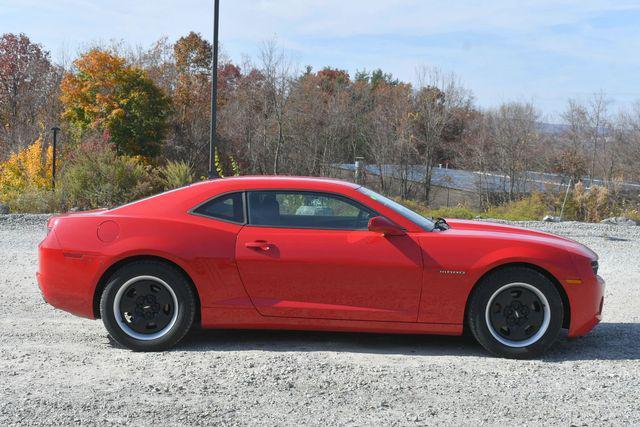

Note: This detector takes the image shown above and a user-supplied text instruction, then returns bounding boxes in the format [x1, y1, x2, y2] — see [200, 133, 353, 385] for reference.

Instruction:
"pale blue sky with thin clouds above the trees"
[0, 0, 640, 121]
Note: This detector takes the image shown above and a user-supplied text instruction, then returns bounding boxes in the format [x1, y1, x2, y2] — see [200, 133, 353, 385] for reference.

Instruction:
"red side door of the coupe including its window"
[236, 191, 422, 322]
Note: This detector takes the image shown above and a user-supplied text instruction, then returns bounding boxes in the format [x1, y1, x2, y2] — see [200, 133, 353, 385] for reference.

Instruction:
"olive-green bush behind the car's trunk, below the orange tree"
[61, 145, 158, 209]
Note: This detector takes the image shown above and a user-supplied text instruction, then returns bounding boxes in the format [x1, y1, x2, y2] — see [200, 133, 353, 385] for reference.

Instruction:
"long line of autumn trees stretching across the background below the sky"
[0, 32, 640, 209]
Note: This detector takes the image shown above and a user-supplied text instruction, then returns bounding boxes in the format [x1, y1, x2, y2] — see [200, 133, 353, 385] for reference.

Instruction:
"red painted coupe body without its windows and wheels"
[37, 177, 604, 336]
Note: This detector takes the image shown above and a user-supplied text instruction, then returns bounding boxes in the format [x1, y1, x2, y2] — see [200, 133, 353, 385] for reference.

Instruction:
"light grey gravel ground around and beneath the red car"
[0, 215, 640, 425]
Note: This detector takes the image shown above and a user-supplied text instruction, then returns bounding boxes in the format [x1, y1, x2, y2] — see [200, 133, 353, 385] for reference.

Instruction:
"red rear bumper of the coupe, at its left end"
[36, 233, 104, 319]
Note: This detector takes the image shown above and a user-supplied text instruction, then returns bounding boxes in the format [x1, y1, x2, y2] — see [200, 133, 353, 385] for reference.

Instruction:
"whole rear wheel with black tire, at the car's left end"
[100, 260, 196, 351]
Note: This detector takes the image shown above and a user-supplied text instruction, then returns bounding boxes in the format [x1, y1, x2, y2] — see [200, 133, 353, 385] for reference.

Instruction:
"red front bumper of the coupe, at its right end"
[565, 276, 605, 337]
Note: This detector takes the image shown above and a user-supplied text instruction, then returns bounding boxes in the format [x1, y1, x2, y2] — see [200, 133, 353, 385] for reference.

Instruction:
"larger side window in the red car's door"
[248, 191, 376, 230]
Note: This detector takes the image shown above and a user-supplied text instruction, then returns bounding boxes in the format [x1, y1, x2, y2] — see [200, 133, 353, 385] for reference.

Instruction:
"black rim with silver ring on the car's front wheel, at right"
[489, 286, 545, 342]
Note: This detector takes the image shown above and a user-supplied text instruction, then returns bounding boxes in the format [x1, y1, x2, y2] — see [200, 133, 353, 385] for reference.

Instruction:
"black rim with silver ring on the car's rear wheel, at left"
[118, 280, 176, 334]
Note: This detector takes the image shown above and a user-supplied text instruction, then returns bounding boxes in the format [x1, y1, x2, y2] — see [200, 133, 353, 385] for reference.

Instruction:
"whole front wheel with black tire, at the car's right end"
[467, 267, 564, 359]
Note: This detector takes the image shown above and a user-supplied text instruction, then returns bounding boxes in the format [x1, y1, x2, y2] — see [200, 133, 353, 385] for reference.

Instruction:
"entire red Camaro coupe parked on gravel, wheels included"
[38, 177, 604, 358]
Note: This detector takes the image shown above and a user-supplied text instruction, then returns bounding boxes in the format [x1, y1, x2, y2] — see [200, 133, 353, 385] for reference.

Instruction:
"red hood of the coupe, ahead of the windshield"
[447, 219, 598, 260]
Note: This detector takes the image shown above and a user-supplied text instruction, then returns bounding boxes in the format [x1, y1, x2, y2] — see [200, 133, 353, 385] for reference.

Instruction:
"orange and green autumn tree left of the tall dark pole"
[61, 49, 170, 157]
